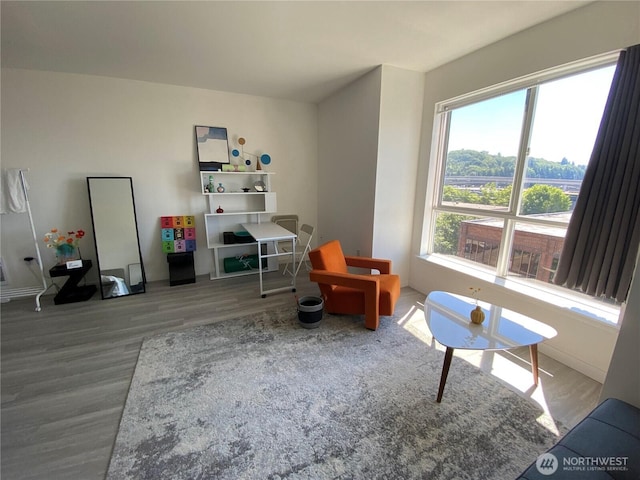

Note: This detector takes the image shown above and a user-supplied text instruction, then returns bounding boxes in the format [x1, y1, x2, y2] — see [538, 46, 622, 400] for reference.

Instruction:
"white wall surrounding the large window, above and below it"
[410, 2, 640, 381]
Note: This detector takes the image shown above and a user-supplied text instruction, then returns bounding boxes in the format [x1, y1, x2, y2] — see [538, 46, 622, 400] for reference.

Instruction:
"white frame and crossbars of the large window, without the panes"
[422, 51, 619, 284]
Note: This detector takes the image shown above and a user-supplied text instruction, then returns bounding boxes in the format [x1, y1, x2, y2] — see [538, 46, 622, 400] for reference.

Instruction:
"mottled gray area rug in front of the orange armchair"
[107, 307, 563, 480]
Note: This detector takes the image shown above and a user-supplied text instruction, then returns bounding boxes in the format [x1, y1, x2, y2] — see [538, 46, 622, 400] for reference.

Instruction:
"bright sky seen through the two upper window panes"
[449, 65, 615, 165]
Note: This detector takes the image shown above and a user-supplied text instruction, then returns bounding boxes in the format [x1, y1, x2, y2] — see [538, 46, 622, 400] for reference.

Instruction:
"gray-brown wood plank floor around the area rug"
[0, 271, 601, 480]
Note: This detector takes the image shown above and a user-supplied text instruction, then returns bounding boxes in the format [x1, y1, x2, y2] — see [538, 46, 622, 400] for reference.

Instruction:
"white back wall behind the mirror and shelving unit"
[1, 69, 318, 286]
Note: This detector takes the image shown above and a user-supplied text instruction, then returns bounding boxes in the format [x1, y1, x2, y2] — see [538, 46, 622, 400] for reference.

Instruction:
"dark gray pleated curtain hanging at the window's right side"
[554, 45, 640, 302]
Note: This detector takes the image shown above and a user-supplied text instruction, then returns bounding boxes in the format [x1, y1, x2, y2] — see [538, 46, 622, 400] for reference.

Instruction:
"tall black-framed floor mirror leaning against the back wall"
[87, 177, 145, 299]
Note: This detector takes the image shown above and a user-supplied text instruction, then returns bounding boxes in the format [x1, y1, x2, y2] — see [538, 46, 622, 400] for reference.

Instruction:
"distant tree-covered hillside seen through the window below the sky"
[446, 150, 586, 180]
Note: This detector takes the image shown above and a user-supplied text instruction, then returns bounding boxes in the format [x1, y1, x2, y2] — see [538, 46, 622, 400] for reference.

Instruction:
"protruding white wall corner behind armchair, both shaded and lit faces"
[318, 65, 424, 286]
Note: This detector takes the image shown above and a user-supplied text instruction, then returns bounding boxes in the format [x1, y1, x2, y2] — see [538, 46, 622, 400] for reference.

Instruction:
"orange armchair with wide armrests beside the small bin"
[309, 240, 400, 330]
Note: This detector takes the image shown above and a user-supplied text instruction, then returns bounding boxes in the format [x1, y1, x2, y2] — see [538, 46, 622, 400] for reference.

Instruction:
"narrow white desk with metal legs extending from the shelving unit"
[242, 222, 297, 298]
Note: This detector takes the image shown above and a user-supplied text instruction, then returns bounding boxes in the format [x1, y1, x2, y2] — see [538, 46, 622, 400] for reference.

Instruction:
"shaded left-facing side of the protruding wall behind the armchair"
[318, 67, 382, 256]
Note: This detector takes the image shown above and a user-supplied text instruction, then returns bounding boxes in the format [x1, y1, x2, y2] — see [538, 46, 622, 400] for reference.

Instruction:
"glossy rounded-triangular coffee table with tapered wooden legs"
[424, 291, 557, 403]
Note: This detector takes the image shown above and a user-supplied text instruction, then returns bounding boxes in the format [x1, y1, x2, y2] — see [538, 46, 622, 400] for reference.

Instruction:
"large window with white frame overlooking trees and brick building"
[426, 62, 615, 300]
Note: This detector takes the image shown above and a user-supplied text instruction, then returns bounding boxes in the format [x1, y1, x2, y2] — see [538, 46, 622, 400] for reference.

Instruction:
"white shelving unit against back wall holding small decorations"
[200, 171, 278, 280]
